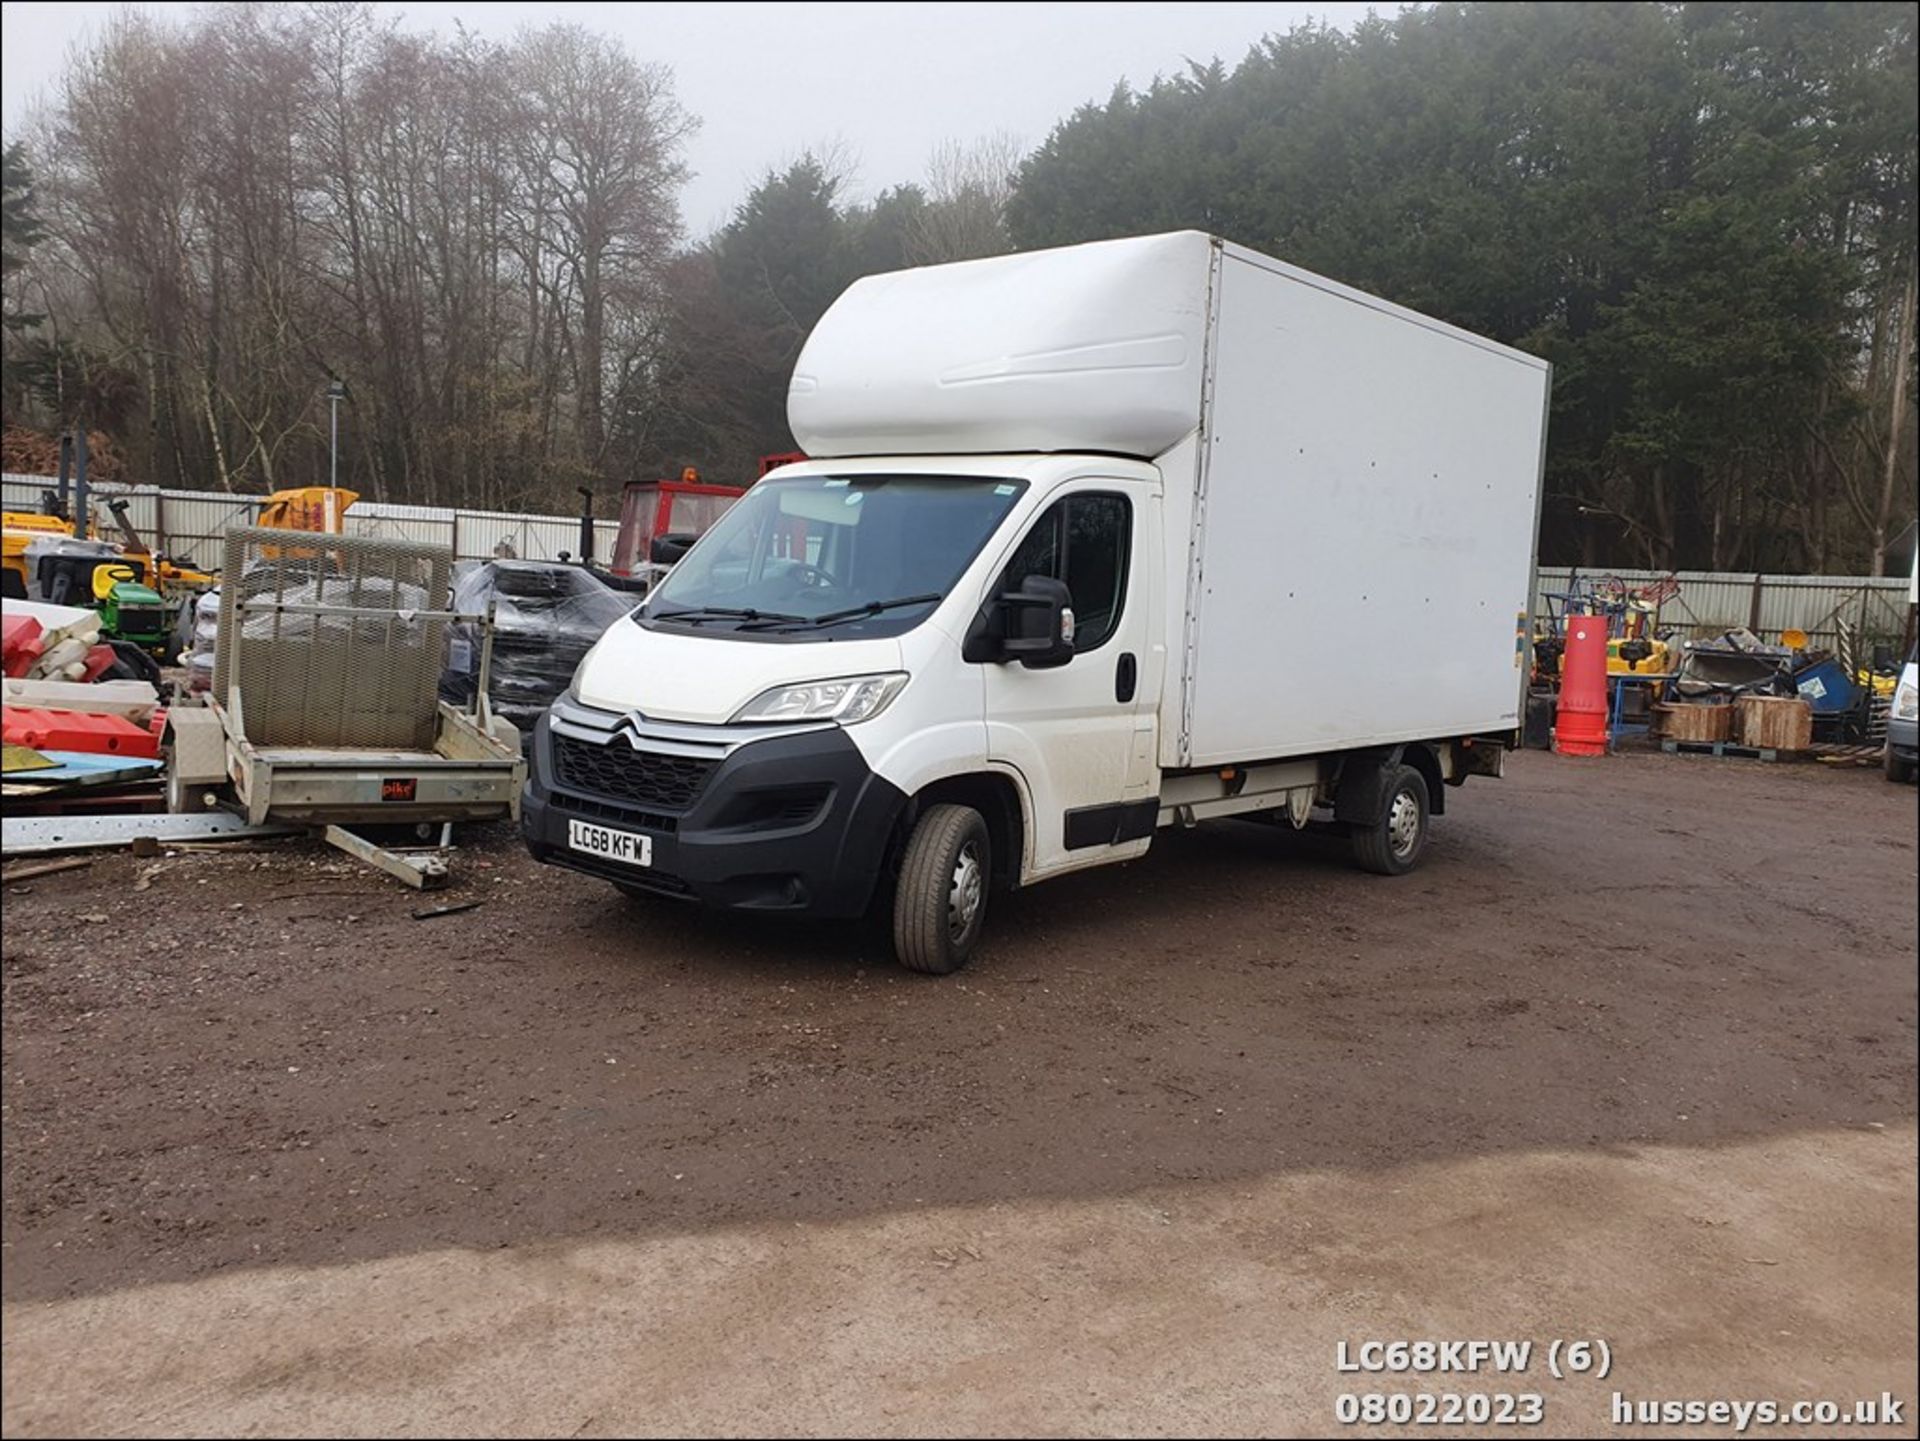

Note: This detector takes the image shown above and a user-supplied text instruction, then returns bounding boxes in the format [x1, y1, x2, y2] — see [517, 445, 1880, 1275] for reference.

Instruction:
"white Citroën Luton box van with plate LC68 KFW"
[522, 232, 1548, 973]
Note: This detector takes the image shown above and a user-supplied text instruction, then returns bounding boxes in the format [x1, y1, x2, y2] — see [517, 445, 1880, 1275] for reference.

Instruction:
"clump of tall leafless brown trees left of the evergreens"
[10, 4, 693, 507]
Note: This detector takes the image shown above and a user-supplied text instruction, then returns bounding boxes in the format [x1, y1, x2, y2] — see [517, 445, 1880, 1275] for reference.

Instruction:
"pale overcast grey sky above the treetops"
[0, 0, 1400, 236]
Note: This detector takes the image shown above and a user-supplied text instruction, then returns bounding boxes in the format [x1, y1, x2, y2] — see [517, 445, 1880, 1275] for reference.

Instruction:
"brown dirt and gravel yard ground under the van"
[0, 754, 1920, 1435]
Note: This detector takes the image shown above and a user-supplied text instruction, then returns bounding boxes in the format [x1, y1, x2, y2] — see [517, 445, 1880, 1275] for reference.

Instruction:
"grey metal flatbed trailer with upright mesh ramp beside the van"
[175, 528, 526, 886]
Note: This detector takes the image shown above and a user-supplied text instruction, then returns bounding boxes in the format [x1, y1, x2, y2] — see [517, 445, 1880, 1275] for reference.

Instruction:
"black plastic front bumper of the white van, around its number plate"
[520, 712, 906, 917]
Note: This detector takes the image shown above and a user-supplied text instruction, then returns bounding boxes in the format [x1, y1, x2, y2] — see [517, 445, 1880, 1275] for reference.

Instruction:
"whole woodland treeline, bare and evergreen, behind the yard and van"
[4, 4, 1920, 572]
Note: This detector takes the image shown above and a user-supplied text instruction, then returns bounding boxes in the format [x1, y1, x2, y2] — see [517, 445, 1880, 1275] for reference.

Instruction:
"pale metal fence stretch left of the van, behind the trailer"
[4, 474, 620, 570]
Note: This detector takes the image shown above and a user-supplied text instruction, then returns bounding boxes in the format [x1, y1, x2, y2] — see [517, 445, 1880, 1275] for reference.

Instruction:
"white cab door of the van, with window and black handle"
[983, 478, 1162, 879]
